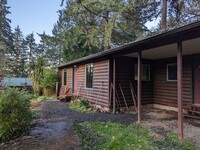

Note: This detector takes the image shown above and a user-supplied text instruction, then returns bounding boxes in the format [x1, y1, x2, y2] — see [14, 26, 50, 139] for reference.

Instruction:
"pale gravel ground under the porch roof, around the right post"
[142, 109, 200, 147]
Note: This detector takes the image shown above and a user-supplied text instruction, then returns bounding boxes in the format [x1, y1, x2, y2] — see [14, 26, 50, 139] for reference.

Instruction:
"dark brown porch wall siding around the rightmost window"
[154, 57, 192, 109]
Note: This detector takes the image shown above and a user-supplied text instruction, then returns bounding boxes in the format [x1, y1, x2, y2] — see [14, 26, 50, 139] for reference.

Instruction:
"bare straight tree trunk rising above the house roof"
[162, 0, 167, 31]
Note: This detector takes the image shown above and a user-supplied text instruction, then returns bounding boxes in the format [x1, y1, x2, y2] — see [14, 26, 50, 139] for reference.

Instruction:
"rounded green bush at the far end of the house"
[41, 69, 58, 96]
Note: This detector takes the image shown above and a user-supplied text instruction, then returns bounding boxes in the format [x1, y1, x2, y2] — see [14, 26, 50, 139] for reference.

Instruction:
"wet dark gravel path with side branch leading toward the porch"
[0, 100, 135, 150]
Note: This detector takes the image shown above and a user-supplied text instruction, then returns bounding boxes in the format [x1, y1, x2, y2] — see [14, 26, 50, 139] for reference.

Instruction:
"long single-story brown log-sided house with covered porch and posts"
[58, 21, 200, 138]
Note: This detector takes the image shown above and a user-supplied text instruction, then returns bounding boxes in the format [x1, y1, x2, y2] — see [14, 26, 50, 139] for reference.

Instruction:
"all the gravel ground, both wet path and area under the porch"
[0, 100, 200, 150]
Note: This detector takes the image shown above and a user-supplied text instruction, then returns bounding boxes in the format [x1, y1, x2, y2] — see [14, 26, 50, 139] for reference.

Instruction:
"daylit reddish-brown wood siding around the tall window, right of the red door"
[77, 60, 109, 107]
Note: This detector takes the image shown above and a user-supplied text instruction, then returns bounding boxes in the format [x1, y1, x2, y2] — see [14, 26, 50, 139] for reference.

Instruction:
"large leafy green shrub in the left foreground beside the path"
[0, 88, 32, 142]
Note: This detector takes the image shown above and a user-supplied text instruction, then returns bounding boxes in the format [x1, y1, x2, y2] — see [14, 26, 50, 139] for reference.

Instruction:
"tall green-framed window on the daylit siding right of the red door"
[85, 64, 94, 88]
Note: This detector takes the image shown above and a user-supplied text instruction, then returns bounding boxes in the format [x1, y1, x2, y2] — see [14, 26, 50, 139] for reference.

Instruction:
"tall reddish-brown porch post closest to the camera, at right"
[177, 42, 183, 139]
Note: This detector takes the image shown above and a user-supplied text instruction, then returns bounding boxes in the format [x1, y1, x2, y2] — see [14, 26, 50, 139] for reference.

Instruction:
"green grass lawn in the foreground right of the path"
[75, 122, 199, 150]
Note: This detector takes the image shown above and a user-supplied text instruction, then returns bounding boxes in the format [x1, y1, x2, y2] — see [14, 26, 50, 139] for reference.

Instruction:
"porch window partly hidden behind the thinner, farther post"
[134, 64, 150, 81]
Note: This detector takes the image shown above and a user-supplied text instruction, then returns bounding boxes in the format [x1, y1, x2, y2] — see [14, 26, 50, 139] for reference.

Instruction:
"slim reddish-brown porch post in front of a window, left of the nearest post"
[137, 52, 142, 123]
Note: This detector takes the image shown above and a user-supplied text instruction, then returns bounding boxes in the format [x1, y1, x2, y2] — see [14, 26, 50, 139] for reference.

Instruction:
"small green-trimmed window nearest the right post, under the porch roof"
[167, 64, 177, 81]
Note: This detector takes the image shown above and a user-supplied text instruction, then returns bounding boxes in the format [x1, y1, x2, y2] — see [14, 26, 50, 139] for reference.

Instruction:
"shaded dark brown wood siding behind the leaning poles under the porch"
[116, 57, 153, 107]
